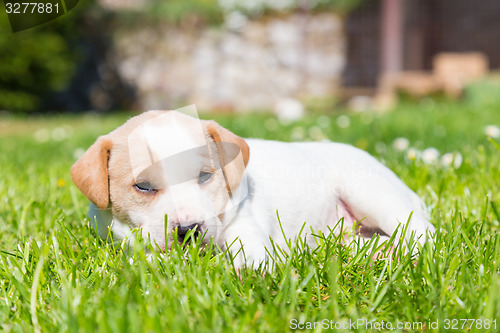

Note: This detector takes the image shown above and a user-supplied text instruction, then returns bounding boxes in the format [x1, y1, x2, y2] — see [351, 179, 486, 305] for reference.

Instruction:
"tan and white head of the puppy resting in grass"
[71, 111, 249, 248]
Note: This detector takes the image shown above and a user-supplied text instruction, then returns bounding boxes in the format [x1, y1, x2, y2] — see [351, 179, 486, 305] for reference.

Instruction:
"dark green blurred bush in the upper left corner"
[0, 0, 94, 113]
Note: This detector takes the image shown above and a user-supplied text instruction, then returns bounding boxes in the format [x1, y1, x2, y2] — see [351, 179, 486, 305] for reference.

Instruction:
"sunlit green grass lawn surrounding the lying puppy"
[0, 100, 500, 332]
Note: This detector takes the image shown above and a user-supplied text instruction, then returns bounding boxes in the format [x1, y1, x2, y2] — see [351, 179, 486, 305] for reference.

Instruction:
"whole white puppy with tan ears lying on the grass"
[71, 111, 434, 267]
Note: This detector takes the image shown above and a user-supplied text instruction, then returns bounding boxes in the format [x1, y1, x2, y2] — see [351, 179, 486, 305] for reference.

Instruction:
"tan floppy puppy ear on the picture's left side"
[71, 136, 112, 209]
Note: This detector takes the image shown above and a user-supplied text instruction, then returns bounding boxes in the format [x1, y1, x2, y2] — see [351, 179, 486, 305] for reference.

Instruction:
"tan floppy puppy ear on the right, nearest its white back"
[206, 121, 250, 194]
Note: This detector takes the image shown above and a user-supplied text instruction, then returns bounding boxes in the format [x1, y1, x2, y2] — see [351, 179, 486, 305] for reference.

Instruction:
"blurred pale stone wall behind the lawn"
[112, 13, 345, 111]
